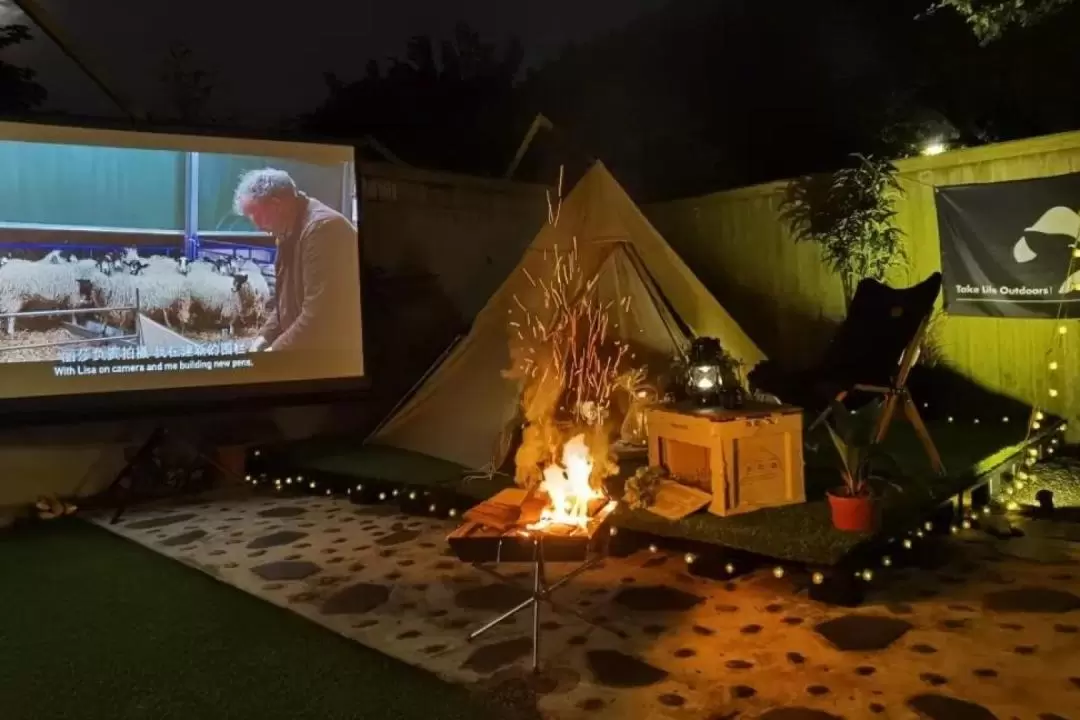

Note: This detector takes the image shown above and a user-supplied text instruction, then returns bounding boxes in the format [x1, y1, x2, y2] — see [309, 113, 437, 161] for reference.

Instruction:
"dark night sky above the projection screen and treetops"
[0, 0, 669, 123]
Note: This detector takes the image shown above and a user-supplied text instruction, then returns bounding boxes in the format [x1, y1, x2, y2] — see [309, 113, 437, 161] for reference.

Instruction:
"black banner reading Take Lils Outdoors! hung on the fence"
[934, 173, 1080, 317]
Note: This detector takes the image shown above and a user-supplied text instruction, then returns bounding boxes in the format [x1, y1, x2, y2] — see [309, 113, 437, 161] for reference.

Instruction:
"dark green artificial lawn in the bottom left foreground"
[0, 519, 491, 720]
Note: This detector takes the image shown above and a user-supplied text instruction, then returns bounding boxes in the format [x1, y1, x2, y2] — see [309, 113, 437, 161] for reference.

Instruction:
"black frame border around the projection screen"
[0, 116, 372, 429]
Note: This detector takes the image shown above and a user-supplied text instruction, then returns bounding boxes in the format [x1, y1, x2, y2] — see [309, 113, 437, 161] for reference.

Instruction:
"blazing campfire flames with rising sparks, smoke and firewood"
[450, 169, 630, 559]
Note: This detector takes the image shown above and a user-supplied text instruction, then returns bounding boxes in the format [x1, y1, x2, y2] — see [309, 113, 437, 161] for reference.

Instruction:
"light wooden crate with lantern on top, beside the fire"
[647, 405, 806, 516]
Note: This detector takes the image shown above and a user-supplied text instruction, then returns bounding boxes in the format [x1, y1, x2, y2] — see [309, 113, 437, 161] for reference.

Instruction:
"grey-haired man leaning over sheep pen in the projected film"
[233, 167, 360, 351]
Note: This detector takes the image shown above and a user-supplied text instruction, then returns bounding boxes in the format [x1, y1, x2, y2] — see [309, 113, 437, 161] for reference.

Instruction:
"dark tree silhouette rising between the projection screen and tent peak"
[301, 25, 528, 174]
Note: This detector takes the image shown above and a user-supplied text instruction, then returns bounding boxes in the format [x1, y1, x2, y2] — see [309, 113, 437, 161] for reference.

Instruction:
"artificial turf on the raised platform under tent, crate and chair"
[289, 408, 1041, 566]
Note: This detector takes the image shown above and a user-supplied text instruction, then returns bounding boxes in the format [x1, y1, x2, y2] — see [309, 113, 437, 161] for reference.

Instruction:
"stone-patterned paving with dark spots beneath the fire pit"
[90, 497, 1080, 720]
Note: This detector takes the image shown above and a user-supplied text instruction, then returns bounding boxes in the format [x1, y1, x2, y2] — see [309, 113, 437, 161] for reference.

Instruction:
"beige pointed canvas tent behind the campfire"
[369, 163, 765, 468]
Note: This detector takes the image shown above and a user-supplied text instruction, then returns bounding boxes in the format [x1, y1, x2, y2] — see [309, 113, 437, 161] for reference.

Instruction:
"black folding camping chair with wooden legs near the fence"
[807, 272, 945, 475]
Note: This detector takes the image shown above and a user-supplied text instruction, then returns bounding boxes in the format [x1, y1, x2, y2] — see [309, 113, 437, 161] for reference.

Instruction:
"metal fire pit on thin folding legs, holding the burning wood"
[447, 502, 616, 673]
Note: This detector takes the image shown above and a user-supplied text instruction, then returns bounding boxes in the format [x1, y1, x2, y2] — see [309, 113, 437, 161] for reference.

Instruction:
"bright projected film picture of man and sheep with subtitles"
[0, 123, 363, 403]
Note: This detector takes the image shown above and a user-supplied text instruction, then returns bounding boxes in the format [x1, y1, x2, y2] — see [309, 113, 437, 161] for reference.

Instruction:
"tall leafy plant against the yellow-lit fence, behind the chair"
[780, 154, 907, 302]
